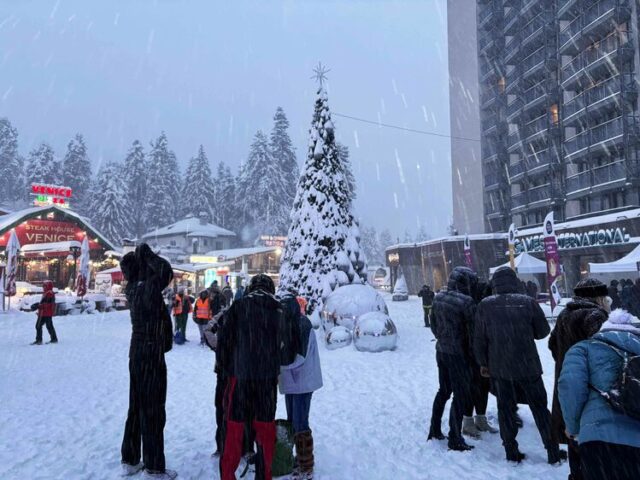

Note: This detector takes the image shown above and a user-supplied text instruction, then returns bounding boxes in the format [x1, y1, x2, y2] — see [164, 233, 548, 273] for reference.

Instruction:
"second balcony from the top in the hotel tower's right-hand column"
[562, 32, 634, 90]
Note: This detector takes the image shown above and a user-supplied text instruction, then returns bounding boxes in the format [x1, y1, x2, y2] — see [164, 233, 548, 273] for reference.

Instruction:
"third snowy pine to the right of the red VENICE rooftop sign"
[124, 140, 149, 238]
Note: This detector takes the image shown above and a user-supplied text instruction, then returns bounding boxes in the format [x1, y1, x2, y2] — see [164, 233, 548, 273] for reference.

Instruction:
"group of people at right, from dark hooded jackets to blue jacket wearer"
[420, 267, 640, 480]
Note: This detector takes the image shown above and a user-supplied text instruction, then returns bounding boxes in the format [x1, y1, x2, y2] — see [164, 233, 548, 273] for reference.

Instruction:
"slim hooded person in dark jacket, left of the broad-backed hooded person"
[429, 267, 478, 451]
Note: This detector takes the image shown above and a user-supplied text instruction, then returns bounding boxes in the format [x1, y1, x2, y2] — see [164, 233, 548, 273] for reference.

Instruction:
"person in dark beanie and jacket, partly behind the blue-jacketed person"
[549, 278, 610, 480]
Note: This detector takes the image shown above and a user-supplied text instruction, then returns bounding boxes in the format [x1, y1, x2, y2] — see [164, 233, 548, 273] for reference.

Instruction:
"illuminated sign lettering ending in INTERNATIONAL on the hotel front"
[516, 227, 630, 253]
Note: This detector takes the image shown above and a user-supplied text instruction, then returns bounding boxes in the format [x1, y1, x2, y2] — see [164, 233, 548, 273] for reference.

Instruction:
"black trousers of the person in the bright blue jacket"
[580, 442, 640, 480]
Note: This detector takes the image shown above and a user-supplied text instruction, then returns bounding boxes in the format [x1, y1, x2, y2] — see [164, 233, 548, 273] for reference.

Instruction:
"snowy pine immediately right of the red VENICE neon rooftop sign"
[62, 134, 91, 213]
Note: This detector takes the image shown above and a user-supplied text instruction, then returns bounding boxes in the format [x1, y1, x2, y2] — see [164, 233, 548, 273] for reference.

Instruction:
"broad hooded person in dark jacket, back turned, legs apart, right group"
[474, 267, 561, 464]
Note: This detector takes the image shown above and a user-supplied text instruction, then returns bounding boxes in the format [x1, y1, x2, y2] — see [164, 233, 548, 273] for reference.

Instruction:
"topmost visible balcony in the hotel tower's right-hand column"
[559, 0, 631, 55]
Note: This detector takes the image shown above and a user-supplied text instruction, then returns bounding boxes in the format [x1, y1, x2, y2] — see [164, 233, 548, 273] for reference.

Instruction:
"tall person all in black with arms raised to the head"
[120, 244, 176, 480]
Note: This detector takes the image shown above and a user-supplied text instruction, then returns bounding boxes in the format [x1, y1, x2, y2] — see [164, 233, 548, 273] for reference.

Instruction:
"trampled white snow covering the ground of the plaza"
[0, 297, 568, 480]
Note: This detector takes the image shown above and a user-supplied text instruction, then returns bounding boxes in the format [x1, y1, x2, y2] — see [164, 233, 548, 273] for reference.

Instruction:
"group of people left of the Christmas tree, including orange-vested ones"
[116, 244, 322, 480]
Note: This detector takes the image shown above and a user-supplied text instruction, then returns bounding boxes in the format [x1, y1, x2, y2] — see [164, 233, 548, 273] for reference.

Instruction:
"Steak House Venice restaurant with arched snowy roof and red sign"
[0, 206, 115, 288]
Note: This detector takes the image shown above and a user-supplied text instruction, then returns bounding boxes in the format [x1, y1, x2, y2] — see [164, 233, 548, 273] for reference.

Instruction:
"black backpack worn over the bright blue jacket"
[589, 339, 640, 420]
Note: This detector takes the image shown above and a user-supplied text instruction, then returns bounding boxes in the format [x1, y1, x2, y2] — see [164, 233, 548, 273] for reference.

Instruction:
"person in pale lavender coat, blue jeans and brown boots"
[280, 293, 322, 480]
